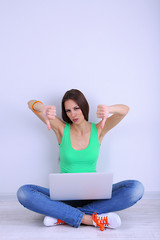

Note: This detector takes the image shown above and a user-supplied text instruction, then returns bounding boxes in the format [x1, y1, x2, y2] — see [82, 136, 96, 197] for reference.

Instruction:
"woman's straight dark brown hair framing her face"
[62, 89, 89, 123]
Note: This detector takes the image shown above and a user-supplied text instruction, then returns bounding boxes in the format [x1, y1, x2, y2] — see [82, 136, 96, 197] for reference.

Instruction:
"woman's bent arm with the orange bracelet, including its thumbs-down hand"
[28, 100, 65, 141]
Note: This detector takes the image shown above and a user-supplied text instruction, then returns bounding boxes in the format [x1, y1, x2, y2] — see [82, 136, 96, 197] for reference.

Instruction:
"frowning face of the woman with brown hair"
[64, 99, 84, 124]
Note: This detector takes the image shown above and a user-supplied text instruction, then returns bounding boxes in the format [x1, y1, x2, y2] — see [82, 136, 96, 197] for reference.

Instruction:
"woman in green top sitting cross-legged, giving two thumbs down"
[17, 89, 144, 231]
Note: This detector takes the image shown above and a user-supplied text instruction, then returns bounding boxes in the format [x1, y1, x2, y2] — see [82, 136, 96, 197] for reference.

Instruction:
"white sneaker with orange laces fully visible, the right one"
[92, 212, 121, 231]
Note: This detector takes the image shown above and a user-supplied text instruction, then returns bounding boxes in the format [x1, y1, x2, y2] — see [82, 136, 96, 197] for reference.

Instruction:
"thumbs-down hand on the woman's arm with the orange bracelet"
[42, 105, 56, 130]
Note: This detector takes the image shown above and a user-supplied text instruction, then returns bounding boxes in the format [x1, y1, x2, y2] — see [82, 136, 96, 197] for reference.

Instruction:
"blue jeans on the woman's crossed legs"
[17, 180, 144, 228]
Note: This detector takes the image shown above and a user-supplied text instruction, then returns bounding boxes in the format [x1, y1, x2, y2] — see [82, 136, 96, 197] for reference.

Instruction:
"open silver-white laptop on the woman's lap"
[49, 172, 113, 200]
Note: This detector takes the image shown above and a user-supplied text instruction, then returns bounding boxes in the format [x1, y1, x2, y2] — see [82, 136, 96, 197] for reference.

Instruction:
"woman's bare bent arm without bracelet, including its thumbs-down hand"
[97, 104, 129, 142]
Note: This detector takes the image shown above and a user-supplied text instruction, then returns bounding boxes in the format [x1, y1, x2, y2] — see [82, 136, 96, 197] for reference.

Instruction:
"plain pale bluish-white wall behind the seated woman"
[0, 0, 160, 193]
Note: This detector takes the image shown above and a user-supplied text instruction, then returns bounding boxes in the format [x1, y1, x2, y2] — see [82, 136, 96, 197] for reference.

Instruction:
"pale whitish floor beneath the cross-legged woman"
[0, 196, 160, 240]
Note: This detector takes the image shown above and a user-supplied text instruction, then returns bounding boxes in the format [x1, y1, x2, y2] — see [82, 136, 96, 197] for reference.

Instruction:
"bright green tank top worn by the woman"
[59, 123, 100, 173]
